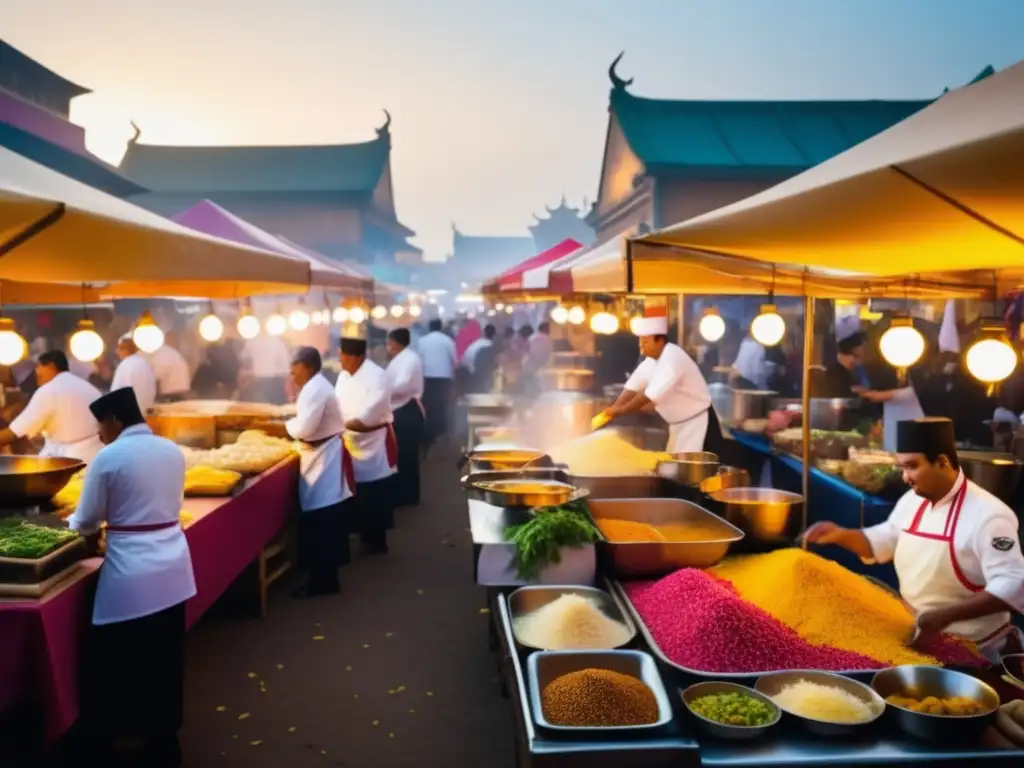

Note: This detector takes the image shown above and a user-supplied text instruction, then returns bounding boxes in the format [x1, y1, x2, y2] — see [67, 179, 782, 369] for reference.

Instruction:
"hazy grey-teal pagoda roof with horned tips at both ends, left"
[121, 118, 391, 194]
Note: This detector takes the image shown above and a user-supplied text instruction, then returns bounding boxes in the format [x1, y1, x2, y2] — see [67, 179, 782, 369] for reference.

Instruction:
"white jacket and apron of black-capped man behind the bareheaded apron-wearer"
[334, 359, 395, 483]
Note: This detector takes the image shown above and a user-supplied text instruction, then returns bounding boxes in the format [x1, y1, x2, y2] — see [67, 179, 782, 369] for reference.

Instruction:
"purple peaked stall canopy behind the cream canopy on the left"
[171, 200, 360, 290]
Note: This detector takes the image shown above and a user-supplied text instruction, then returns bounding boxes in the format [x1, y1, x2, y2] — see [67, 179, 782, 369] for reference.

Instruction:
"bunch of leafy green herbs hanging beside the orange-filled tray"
[505, 501, 598, 582]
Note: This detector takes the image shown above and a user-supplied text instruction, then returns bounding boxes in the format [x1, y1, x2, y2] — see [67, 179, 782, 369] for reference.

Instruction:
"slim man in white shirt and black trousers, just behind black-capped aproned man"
[386, 328, 425, 507]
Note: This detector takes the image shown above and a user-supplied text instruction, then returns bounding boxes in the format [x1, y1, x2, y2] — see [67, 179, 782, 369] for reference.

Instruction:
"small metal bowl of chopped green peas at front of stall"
[682, 681, 782, 740]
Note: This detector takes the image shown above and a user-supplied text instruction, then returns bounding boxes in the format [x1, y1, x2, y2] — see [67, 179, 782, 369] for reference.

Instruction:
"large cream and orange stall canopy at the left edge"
[0, 147, 310, 296]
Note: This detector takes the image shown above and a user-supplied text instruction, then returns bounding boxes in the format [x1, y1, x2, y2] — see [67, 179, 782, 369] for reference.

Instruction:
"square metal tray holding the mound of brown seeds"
[526, 650, 673, 736]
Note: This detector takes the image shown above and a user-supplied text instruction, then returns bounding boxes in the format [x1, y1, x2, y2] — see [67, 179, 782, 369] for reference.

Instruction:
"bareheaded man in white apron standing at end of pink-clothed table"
[285, 347, 355, 597]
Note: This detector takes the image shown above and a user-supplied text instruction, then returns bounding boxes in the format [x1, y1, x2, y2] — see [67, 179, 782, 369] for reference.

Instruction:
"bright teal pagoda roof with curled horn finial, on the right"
[609, 52, 933, 172]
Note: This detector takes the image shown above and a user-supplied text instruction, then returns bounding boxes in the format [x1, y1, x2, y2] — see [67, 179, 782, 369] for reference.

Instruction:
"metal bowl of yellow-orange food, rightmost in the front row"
[871, 665, 999, 741]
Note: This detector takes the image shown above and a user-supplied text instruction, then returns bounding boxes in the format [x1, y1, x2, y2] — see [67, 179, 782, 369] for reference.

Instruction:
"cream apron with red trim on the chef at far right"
[893, 480, 1013, 657]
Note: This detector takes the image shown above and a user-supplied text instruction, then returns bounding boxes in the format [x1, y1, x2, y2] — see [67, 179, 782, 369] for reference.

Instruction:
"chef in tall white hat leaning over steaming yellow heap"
[605, 314, 724, 455]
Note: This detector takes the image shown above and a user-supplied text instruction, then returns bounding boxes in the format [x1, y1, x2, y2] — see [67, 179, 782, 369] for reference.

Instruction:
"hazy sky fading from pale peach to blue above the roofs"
[0, 0, 1024, 258]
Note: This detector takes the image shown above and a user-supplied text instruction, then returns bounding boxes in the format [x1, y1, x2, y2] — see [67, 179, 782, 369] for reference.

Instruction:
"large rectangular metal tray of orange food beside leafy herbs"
[589, 499, 743, 578]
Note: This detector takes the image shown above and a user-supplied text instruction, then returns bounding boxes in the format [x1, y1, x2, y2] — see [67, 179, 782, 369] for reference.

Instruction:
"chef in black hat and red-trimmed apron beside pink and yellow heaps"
[804, 419, 1024, 660]
